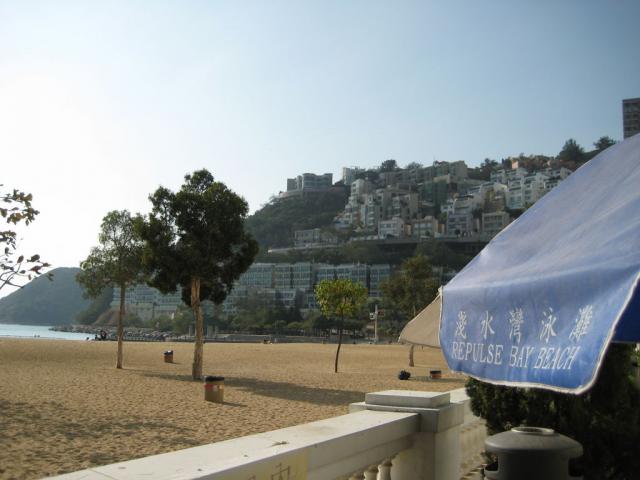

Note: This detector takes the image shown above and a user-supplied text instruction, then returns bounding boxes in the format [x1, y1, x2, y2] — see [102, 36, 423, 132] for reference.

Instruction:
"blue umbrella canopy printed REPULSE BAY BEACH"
[440, 135, 640, 393]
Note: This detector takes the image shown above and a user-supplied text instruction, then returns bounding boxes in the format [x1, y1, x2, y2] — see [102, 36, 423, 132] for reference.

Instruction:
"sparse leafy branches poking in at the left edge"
[0, 184, 51, 290]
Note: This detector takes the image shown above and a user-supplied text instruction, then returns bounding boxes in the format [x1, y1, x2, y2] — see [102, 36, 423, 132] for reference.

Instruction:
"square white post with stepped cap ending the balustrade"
[349, 390, 464, 480]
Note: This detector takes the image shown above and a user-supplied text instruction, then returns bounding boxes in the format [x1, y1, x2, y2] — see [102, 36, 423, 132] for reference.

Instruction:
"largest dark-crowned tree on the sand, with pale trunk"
[139, 170, 258, 380]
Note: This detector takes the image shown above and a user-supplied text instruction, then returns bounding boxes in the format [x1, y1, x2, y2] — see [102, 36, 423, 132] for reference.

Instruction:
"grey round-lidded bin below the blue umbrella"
[484, 427, 582, 480]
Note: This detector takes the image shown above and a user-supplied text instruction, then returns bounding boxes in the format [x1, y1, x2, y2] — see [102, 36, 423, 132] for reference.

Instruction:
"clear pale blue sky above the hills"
[0, 0, 640, 293]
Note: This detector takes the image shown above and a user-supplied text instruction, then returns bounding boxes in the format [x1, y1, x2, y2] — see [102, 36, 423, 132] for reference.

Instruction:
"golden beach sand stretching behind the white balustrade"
[0, 339, 464, 479]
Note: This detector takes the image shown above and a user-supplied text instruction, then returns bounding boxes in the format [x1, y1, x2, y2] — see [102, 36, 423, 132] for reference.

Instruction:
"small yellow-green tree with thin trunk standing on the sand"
[316, 278, 367, 373]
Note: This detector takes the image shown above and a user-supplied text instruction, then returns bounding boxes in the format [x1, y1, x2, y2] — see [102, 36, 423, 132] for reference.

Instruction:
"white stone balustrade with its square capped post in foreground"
[50, 390, 484, 480]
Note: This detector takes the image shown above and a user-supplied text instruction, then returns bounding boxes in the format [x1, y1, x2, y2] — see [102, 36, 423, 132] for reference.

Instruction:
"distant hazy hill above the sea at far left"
[0, 268, 90, 325]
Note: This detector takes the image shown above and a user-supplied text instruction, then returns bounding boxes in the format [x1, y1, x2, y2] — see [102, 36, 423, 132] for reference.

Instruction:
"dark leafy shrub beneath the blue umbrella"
[467, 344, 640, 480]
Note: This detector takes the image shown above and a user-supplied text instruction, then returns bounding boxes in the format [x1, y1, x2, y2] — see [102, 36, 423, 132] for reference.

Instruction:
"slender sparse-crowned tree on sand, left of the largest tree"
[76, 210, 144, 368]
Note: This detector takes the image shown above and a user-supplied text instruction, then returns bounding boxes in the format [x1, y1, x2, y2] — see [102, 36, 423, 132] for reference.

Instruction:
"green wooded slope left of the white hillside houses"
[246, 188, 349, 251]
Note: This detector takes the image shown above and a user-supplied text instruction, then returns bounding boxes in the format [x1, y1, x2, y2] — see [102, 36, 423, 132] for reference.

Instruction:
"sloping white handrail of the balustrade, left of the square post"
[50, 411, 420, 480]
